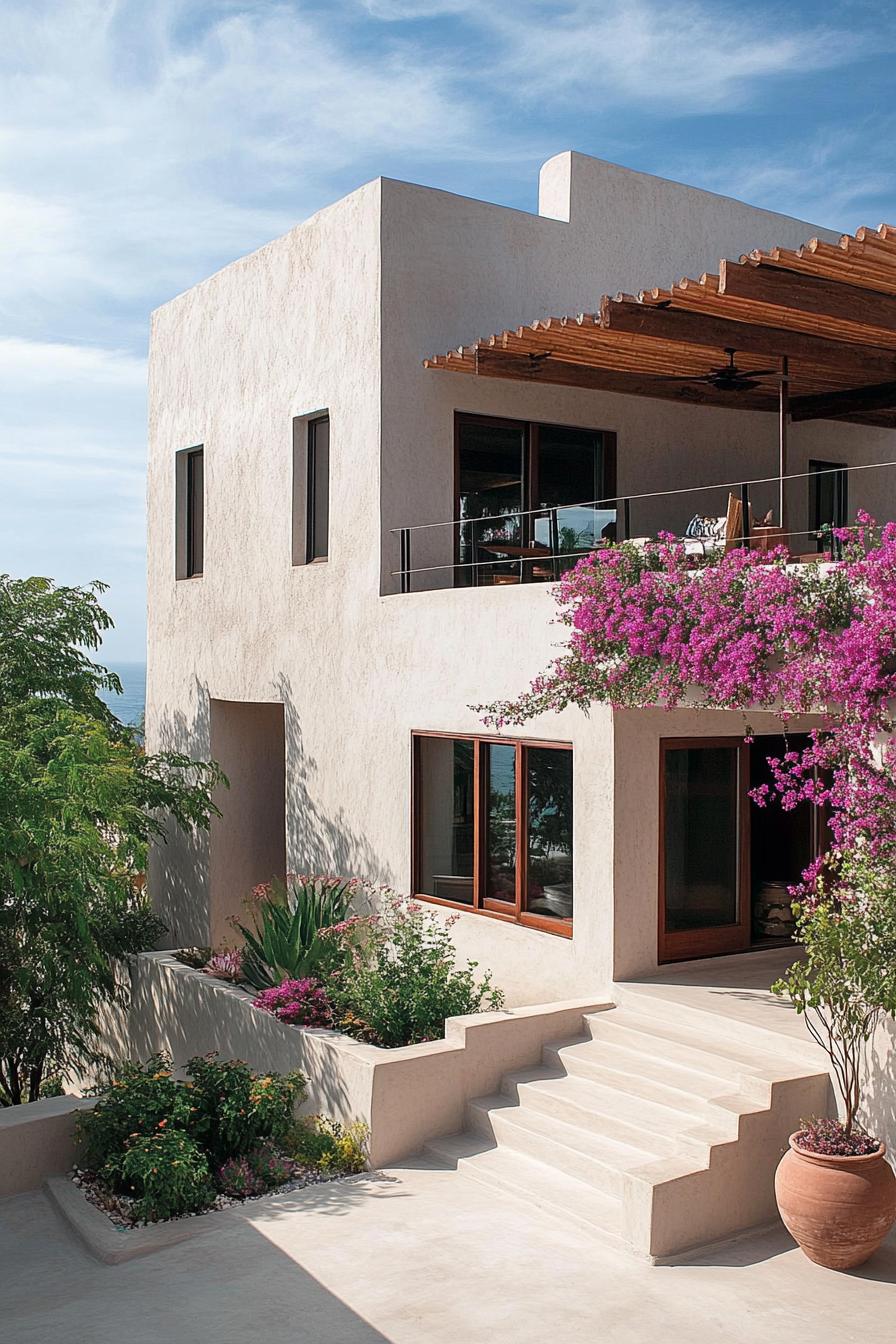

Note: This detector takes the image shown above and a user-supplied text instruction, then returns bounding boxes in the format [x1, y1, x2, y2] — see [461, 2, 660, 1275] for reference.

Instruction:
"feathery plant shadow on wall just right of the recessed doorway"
[278, 676, 395, 883]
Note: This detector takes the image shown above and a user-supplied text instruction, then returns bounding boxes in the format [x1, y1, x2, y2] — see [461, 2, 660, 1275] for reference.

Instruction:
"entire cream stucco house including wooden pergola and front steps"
[138, 153, 896, 1255]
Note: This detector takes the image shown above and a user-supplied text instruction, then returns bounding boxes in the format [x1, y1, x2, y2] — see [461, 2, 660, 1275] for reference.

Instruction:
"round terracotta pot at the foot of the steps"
[775, 1134, 896, 1269]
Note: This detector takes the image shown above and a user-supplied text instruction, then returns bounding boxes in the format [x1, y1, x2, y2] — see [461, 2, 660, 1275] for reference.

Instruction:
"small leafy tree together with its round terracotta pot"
[772, 845, 896, 1269]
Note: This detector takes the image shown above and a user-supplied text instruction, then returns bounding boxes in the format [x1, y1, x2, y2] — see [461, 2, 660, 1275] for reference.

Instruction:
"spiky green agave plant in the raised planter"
[236, 878, 355, 989]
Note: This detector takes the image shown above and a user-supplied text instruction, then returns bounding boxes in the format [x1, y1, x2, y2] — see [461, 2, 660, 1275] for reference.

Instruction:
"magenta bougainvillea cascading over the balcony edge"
[478, 513, 896, 905]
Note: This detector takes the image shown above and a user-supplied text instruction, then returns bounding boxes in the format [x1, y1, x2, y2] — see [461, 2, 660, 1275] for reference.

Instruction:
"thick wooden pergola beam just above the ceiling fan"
[600, 296, 896, 382]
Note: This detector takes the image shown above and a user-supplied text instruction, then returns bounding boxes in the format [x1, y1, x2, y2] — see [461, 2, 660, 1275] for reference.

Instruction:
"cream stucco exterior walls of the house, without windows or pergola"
[146, 155, 892, 1004]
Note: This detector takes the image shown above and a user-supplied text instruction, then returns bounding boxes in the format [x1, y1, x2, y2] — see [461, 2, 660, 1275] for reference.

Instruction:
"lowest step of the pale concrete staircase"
[423, 1133, 622, 1246]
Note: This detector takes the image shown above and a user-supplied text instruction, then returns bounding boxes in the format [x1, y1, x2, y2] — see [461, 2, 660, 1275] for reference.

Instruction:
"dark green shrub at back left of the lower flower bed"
[78, 1054, 191, 1169]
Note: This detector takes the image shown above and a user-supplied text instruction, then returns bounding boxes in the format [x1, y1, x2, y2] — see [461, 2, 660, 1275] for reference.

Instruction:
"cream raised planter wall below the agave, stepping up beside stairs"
[105, 952, 609, 1167]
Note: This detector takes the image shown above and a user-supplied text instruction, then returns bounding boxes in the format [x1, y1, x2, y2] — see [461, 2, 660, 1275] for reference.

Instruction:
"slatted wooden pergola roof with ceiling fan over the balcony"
[424, 224, 896, 427]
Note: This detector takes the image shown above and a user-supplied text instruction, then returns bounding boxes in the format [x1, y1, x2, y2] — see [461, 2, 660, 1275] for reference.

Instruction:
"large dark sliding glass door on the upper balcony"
[455, 415, 617, 586]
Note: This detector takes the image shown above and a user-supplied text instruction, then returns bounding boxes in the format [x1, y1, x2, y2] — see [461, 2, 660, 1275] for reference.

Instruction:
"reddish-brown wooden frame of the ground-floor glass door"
[657, 737, 752, 964]
